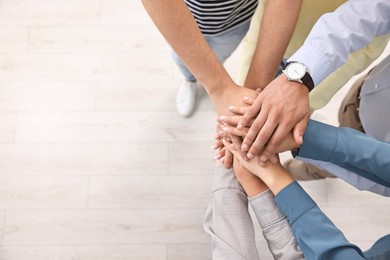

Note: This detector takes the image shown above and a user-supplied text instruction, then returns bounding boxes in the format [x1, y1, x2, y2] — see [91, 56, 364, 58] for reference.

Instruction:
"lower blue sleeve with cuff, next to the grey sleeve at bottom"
[275, 182, 365, 260]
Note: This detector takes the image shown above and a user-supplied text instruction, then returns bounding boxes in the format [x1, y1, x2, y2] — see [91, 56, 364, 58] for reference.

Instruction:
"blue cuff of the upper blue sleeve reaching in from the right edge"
[297, 120, 338, 162]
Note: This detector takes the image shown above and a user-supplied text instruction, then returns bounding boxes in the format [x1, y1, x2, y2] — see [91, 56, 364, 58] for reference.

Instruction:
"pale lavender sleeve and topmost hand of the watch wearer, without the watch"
[238, 0, 390, 161]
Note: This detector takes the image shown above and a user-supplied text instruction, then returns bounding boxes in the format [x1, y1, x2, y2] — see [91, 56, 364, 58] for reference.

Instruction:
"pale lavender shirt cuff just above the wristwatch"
[287, 44, 335, 86]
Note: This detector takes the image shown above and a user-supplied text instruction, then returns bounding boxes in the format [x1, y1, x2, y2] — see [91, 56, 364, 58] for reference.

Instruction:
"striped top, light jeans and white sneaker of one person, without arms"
[172, 0, 258, 117]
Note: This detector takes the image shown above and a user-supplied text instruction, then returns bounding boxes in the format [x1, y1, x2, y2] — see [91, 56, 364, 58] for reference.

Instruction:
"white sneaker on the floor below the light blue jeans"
[176, 80, 198, 117]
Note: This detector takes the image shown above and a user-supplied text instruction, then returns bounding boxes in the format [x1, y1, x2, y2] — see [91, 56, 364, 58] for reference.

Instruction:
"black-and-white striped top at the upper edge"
[184, 0, 257, 35]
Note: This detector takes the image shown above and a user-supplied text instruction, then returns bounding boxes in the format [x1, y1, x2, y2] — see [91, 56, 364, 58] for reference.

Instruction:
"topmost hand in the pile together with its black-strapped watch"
[237, 61, 314, 162]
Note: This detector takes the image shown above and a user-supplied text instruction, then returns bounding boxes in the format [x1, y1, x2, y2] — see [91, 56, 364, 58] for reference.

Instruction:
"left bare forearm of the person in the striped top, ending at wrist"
[142, 0, 231, 95]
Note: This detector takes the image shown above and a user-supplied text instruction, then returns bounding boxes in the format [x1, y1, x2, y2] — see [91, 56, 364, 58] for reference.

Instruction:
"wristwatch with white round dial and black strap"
[282, 61, 314, 92]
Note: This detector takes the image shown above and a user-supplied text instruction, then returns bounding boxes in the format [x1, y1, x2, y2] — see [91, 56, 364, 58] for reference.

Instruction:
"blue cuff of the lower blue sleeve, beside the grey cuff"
[275, 181, 317, 226]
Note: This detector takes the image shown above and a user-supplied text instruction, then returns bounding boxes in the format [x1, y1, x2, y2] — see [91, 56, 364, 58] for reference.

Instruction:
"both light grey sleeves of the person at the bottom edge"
[204, 165, 304, 260]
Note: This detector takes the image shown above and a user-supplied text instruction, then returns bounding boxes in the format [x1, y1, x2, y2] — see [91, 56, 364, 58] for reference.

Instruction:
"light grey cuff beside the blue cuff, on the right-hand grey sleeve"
[249, 190, 284, 229]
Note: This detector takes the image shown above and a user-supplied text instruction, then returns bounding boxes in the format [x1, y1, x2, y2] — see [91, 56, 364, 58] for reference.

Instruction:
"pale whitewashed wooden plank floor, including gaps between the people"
[0, 0, 390, 260]
